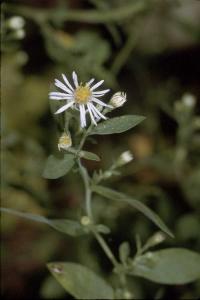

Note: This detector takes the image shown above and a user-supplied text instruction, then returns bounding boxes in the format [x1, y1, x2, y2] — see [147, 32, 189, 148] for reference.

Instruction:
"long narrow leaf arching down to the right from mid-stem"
[92, 185, 174, 237]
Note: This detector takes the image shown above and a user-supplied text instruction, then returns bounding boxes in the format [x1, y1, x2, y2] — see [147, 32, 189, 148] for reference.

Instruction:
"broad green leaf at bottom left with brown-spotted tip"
[47, 262, 114, 299]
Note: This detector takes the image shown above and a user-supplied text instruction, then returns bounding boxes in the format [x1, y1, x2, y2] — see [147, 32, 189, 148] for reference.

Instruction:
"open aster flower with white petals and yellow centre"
[49, 72, 112, 127]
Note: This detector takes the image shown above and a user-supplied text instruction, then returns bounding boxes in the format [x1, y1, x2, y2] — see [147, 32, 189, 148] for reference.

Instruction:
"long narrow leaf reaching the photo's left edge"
[0, 207, 85, 236]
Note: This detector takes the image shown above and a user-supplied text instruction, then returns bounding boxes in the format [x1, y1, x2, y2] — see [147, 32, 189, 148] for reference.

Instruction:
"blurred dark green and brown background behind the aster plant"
[1, 0, 200, 299]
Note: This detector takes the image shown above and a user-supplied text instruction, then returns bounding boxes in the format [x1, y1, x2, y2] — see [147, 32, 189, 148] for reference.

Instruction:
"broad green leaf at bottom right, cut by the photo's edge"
[131, 248, 200, 284]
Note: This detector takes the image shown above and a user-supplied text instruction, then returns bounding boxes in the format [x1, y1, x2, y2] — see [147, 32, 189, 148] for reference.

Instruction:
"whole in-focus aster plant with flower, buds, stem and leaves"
[1, 72, 200, 299]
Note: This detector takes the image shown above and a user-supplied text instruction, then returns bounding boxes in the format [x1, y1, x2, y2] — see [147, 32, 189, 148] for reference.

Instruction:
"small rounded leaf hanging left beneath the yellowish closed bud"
[43, 154, 74, 179]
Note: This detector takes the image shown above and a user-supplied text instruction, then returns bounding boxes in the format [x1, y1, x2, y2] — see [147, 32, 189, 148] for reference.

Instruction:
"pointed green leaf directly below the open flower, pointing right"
[90, 115, 145, 135]
